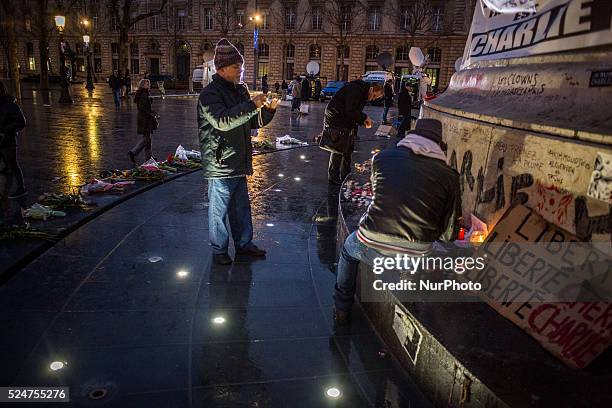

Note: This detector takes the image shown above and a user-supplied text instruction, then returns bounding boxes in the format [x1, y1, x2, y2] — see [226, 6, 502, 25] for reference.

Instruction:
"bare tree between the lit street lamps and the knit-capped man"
[109, 0, 168, 71]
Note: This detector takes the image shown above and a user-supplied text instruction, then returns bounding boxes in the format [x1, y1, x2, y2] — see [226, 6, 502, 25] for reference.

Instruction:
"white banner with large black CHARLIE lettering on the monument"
[463, 0, 612, 68]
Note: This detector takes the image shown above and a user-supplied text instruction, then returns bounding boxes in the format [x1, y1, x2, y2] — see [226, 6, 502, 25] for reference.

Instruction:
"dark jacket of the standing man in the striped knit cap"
[197, 74, 275, 178]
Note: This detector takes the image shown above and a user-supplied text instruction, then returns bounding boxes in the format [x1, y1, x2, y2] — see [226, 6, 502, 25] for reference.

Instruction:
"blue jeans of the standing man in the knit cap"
[208, 176, 253, 254]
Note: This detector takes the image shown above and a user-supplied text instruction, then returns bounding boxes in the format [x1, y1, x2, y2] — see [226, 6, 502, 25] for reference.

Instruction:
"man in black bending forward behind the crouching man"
[323, 79, 383, 185]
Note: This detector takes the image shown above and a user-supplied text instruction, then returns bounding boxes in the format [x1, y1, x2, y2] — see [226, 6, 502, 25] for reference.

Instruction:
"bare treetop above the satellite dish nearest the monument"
[386, 0, 434, 49]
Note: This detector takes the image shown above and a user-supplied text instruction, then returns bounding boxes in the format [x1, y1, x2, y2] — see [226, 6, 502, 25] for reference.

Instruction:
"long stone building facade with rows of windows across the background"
[0, 0, 475, 88]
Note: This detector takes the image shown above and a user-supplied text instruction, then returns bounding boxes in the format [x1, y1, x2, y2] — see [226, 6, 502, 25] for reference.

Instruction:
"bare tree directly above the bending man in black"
[321, 0, 367, 80]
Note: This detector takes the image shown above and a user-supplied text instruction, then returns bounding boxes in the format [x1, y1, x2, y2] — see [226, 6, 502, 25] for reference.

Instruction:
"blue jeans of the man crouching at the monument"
[334, 232, 393, 313]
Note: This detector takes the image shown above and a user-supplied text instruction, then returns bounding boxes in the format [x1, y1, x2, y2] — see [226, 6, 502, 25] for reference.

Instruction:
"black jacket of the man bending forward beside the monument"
[324, 79, 370, 129]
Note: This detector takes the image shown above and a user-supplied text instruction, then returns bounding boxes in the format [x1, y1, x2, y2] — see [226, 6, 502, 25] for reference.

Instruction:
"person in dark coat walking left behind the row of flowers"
[128, 79, 157, 167]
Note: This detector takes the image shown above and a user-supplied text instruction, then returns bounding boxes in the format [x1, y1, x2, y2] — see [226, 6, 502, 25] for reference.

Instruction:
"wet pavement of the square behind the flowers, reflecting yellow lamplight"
[13, 84, 368, 204]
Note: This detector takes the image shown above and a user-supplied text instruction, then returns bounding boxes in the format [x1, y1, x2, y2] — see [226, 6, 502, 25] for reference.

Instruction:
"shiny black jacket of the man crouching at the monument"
[358, 147, 461, 252]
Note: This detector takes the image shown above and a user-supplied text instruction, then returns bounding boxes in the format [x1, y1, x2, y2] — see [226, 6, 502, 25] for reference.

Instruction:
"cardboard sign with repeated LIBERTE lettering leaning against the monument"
[465, 205, 612, 368]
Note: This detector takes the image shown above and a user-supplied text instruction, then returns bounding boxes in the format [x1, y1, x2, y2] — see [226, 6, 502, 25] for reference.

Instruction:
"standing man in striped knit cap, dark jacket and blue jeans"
[198, 38, 278, 265]
